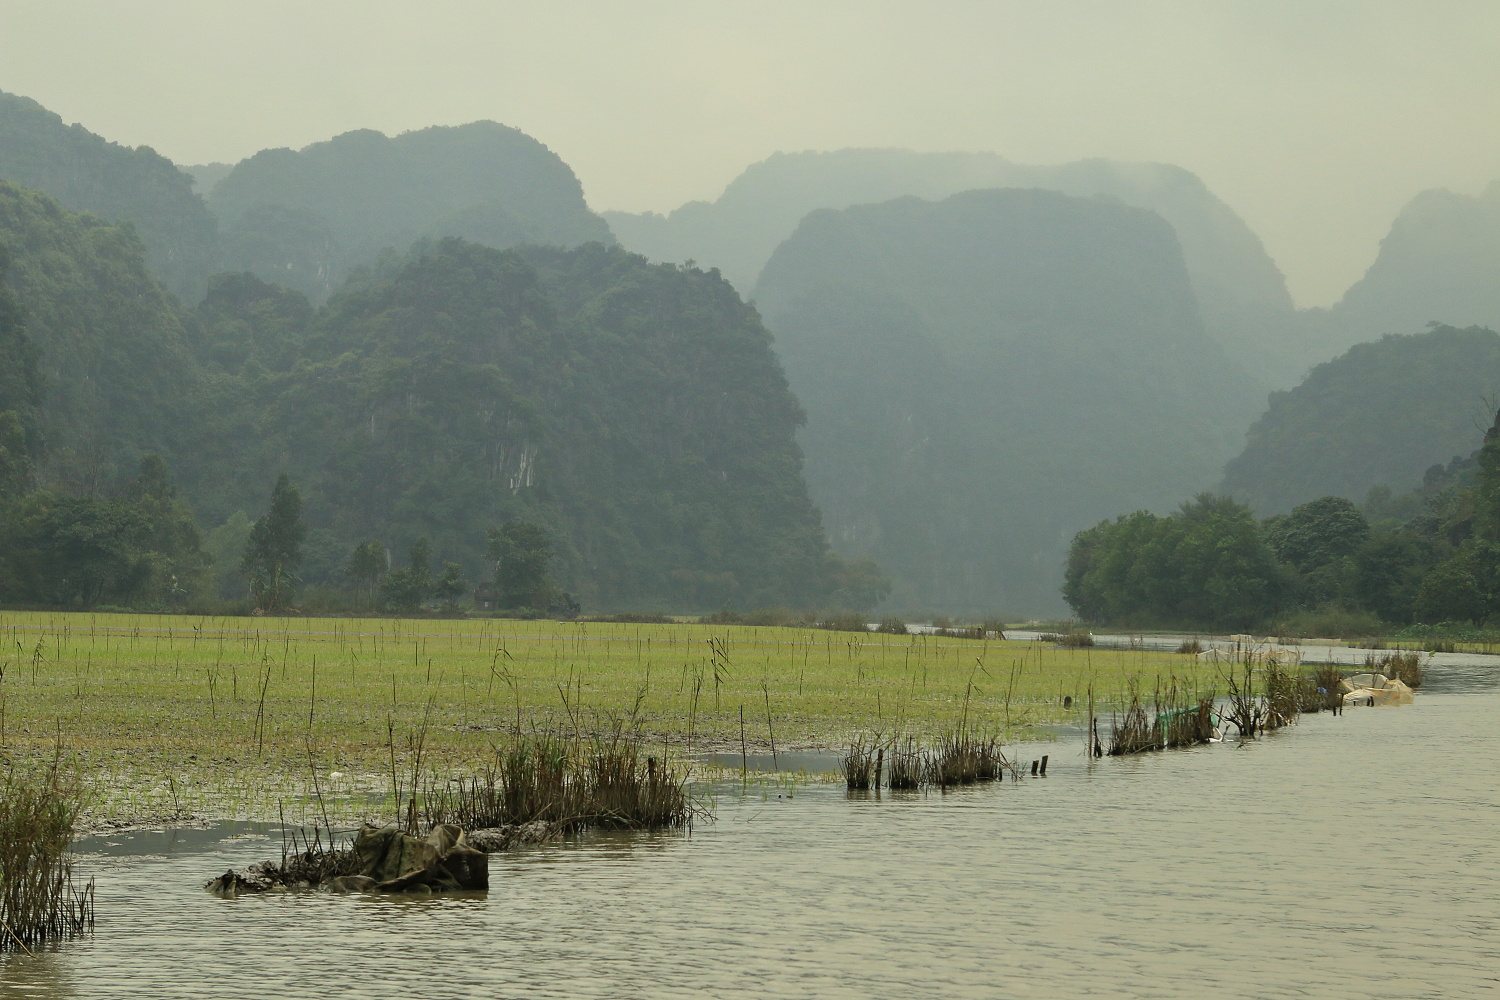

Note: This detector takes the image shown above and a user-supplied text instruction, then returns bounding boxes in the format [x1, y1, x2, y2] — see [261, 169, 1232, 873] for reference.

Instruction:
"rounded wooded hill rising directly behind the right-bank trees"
[1218, 327, 1500, 517]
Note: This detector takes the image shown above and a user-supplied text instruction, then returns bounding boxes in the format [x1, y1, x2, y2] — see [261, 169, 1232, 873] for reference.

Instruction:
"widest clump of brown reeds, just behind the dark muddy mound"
[423, 732, 698, 831]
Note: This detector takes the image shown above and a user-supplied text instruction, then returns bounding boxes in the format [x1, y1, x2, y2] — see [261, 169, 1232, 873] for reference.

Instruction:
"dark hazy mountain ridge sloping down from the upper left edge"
[0, 93, 216, 301]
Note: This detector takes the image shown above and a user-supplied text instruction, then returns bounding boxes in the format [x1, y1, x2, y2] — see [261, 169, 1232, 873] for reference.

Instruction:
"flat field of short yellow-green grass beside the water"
[0, 612, 1223, 819]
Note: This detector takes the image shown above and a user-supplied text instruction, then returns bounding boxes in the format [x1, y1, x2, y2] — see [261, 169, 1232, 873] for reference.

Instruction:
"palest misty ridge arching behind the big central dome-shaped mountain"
[605, 148, 1335, 385]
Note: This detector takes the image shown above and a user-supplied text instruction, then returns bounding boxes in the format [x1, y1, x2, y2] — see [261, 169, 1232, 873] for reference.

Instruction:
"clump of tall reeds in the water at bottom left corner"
[0, 754, 95, 951]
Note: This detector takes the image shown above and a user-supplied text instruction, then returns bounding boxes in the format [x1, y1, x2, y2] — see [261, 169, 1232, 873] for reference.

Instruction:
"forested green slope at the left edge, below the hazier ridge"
[0, 181, 204, 492]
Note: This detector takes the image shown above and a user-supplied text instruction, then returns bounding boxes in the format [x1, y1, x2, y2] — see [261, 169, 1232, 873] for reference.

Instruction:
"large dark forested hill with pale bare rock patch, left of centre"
[185, 238, 869, 609]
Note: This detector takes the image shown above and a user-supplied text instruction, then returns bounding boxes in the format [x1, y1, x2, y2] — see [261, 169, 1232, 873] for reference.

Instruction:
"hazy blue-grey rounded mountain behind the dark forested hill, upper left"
[207, 121, 614, 301]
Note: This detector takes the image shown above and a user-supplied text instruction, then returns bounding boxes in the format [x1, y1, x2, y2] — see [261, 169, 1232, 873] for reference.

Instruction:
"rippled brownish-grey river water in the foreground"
[0, 660, 1500, 1000]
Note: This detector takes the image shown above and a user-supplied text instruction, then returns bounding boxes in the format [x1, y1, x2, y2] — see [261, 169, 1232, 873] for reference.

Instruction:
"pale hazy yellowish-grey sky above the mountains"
[0, 0, 1500, 304]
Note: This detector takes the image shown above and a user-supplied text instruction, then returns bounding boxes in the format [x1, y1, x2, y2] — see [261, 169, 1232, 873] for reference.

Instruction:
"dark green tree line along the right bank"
[1064, 414, 1500, 630]
